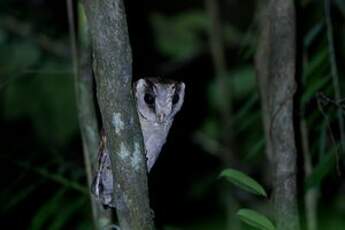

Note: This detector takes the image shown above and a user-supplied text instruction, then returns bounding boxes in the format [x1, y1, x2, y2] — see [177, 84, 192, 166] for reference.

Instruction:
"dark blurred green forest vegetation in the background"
[0, 0, 345, 230]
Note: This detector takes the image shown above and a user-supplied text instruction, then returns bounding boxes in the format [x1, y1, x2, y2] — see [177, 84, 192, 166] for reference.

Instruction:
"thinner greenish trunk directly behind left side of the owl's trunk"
[73, 1, 112, 230]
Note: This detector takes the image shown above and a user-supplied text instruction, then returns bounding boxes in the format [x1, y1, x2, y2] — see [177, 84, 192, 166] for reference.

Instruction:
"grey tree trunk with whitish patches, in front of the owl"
[80, 0, 154, 230]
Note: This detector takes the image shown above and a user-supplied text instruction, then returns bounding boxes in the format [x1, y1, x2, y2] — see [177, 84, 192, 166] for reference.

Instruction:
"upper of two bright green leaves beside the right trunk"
[220, 169, 267, 197]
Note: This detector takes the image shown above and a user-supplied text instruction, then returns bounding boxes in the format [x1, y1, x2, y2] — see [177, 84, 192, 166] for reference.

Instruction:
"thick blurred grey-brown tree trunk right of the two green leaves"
[256, 0, 300, 230]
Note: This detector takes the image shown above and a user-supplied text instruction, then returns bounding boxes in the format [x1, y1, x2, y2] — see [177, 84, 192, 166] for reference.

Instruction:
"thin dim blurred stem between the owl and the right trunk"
[205, 0, 240, 229]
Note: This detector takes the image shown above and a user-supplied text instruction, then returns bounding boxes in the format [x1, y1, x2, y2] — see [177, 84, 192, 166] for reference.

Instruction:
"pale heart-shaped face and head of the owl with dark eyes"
[134, 78, 185, 123]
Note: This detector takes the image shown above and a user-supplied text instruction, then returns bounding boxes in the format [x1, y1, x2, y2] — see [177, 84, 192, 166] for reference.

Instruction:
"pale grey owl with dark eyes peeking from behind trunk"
[91, 78, 185, 207]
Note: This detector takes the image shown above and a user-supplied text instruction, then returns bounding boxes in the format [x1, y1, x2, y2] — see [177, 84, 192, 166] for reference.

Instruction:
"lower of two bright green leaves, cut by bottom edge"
[237, 209, 276, 230]
